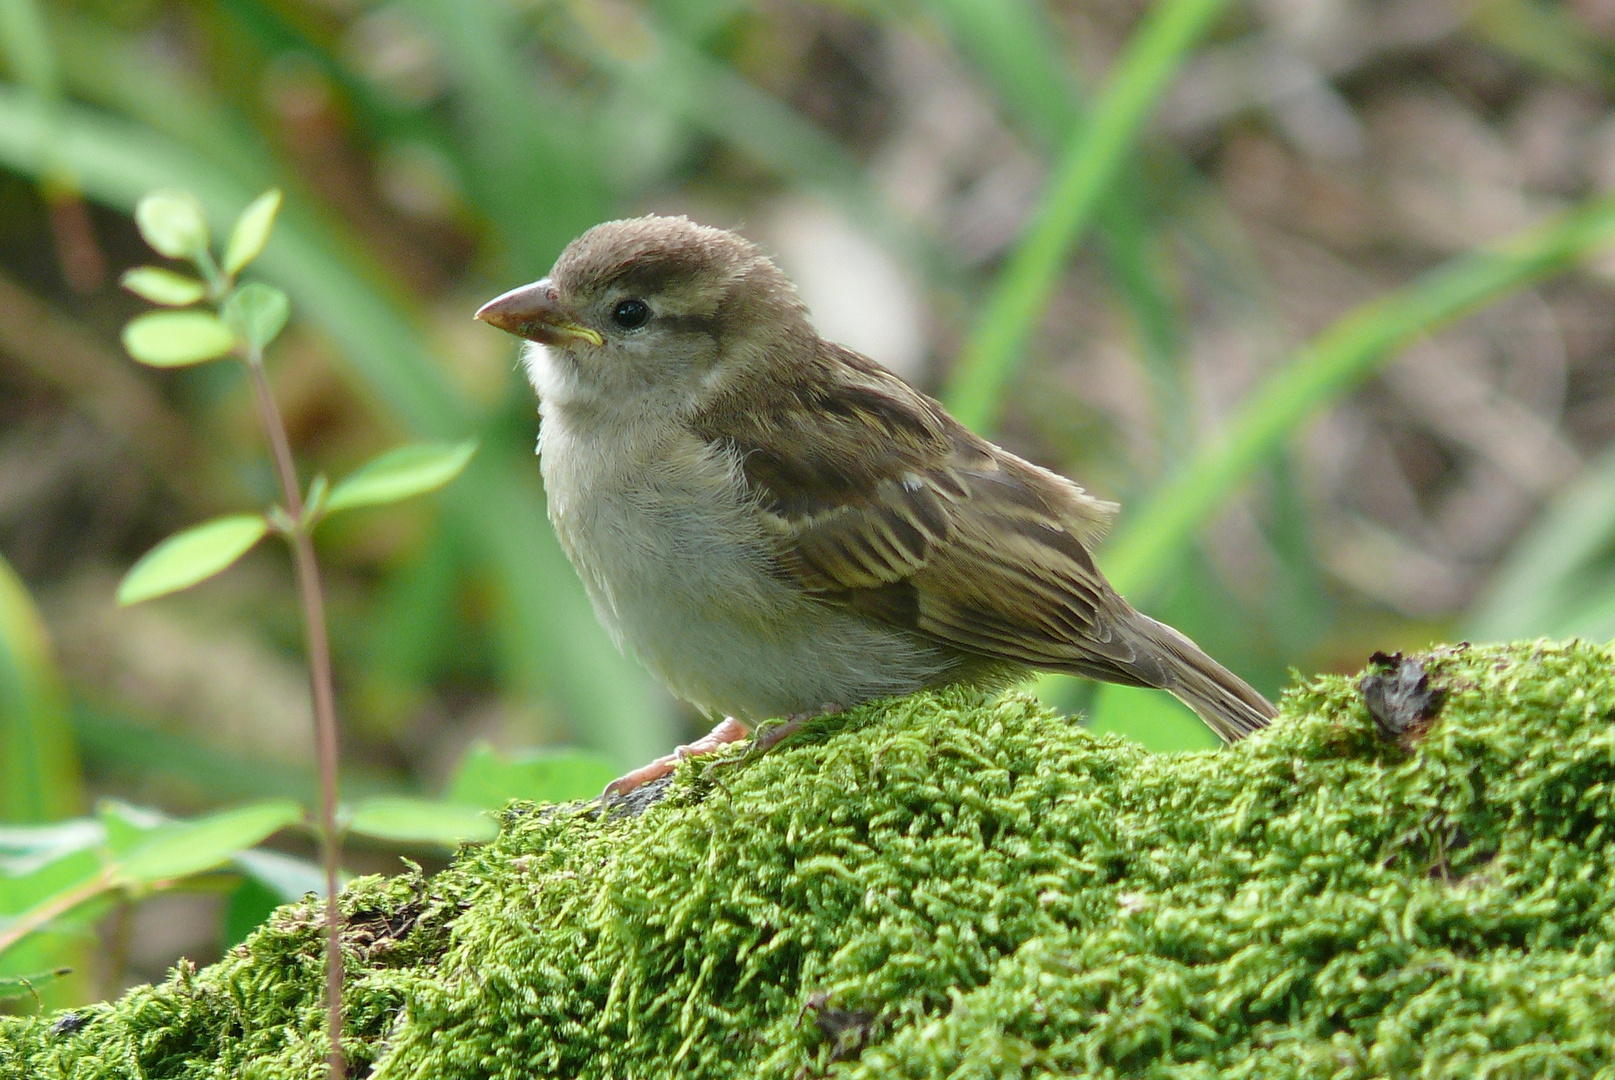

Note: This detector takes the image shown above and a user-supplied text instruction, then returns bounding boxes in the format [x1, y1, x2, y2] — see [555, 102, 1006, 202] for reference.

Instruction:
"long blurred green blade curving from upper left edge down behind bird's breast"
[0, 86, 675, 765]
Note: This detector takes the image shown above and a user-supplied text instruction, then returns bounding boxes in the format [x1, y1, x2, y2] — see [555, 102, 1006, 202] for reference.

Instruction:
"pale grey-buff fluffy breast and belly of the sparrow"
[541, 413, 948, 720]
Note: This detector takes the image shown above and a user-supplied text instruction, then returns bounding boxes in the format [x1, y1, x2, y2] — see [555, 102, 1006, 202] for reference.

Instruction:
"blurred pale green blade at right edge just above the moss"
[1465, 439, 1615, 641]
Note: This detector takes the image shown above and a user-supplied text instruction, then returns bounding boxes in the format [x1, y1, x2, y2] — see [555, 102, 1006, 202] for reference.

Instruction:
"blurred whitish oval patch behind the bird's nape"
[757, 197, 927, 381]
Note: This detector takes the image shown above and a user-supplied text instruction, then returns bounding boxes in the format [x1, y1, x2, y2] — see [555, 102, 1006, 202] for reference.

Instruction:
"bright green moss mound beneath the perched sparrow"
[0, 643, 1615, 1080]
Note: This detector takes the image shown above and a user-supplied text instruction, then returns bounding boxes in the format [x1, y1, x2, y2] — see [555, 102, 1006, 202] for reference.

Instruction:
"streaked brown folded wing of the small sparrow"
[703, 347, 1134, 678]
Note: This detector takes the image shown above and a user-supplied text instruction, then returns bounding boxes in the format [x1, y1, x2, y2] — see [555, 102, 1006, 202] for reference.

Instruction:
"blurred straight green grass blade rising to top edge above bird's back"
[943, 0, 1224, 429]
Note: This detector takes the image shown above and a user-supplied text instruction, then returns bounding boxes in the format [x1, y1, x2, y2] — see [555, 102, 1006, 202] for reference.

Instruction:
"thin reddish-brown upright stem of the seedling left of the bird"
[235, 349, 344, 1080]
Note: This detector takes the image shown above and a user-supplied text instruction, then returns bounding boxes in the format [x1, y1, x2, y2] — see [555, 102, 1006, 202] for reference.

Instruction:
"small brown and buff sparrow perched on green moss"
[476, 215, 1276, 794]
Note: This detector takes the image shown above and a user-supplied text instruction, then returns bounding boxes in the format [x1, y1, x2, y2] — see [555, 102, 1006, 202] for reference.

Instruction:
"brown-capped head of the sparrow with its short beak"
[476, 216, 816, 408]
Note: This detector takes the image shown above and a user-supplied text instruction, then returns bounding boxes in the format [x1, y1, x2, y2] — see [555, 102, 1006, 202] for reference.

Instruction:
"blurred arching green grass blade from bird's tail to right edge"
[1103, 199, 1615, 599]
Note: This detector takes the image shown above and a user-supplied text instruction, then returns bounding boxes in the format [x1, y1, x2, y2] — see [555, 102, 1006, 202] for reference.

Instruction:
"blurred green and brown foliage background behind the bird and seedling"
[0, 0, 1615, 996]
